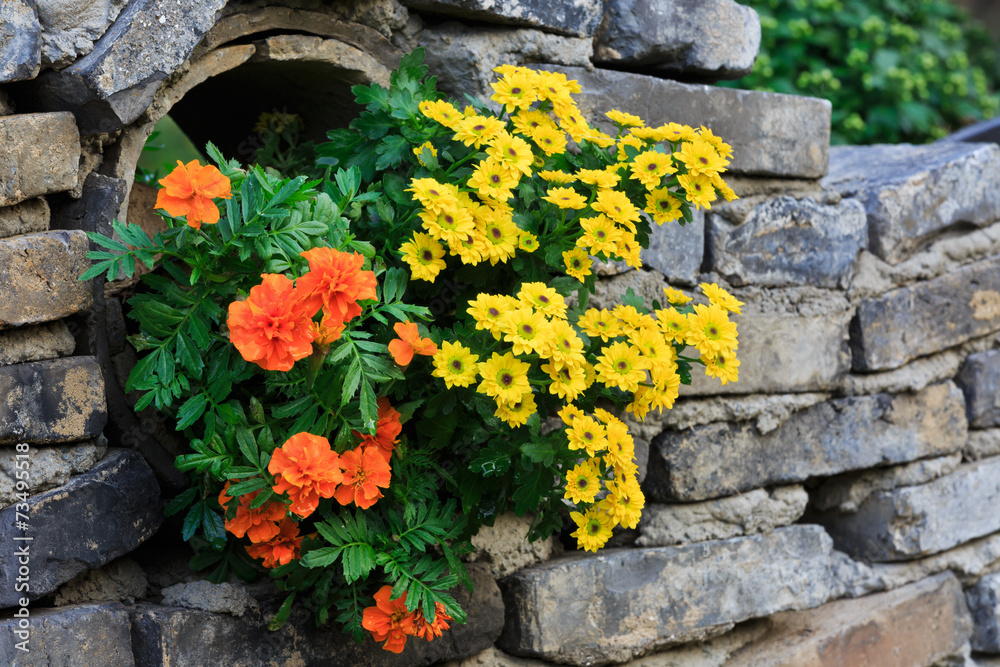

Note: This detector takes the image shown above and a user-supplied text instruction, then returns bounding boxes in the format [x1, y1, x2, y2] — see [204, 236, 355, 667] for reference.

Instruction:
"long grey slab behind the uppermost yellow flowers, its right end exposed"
[554, 67, 831, 178]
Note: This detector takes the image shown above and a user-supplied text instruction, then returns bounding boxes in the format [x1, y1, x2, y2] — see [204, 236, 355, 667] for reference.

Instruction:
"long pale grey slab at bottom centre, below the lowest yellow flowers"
[497, 526, 868, 665]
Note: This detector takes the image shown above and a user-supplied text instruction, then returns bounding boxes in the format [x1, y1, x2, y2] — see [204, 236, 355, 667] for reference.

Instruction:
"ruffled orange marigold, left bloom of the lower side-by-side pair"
[267, 433, 344, 518]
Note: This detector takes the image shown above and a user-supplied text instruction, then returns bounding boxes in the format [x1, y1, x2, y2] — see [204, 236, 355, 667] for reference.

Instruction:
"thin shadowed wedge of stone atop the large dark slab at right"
[812, 452, 962, 512]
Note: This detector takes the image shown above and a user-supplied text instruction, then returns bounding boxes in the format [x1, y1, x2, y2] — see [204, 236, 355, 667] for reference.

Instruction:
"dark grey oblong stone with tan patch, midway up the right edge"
[851, 254, 1000, 371]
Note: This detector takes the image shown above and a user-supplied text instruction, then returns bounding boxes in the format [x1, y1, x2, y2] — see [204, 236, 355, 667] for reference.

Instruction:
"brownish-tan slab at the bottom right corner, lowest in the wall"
[726, 573, 972, 667]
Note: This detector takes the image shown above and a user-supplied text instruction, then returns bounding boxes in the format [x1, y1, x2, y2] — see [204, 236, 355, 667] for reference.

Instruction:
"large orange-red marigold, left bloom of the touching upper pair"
[226, 273, 316, 371]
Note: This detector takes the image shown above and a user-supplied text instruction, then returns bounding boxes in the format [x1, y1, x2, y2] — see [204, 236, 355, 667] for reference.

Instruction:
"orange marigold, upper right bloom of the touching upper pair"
[298, 248, 375, 322]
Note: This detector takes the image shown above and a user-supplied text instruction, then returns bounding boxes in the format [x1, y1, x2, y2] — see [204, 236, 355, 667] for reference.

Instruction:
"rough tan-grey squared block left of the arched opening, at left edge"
[0, 113, 80, 206]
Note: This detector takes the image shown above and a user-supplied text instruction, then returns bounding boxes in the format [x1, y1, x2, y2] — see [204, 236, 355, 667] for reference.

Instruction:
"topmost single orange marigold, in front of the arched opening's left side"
[156, 160, 233, 229]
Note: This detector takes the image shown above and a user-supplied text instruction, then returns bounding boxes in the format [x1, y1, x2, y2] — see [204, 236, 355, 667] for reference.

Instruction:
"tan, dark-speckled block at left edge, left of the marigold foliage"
[0, 231, 93, 329]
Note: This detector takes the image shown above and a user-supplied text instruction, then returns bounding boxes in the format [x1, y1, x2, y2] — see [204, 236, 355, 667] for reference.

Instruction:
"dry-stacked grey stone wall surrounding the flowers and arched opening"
[0, 0, 1000, 667]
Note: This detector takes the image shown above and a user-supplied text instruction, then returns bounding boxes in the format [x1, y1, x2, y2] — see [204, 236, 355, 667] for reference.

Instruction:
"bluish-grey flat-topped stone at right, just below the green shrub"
[822, 142, 1000, 264]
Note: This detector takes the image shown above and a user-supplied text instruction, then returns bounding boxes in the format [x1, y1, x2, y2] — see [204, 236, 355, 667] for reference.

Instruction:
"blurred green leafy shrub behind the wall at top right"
[723, 0, 1000, 144]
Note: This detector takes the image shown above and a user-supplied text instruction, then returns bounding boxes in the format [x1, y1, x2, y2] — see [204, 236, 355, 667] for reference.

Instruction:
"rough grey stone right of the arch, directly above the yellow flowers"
[417, 23, 593, 99]
